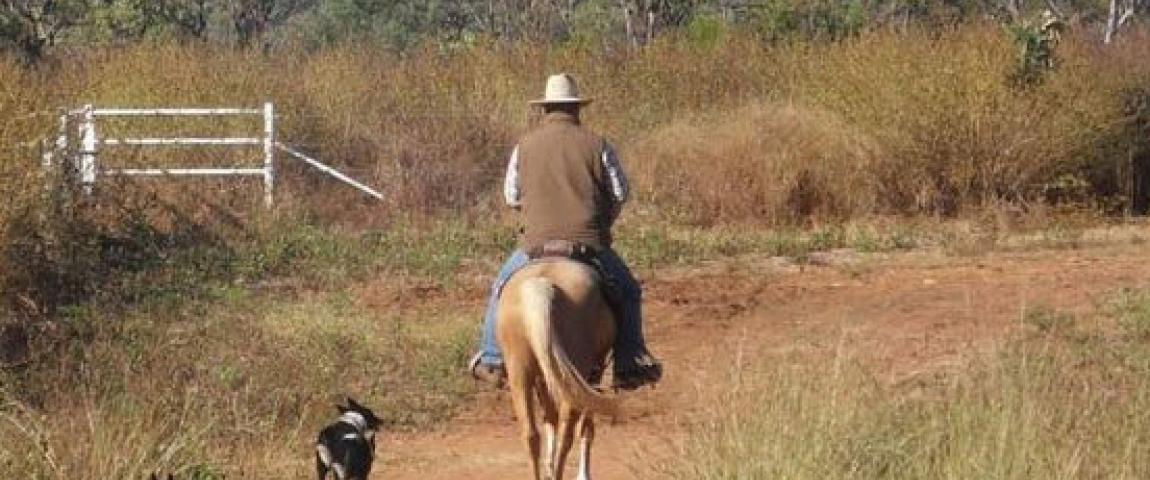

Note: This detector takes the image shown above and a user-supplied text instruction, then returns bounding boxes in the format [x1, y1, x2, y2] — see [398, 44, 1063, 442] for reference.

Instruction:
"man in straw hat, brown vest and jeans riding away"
[469, 74, 662, 389]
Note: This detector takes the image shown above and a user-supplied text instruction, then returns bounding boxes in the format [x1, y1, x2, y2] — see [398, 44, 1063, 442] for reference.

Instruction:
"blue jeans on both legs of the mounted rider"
[480, 249, 646, 365]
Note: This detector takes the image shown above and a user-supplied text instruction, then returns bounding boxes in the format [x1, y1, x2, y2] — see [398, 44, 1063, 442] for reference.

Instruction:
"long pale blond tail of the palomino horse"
[520, 277, 618, 416]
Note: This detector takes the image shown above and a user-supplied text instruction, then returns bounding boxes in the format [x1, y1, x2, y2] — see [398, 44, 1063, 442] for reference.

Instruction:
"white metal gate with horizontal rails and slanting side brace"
[44, 102, 383, 207]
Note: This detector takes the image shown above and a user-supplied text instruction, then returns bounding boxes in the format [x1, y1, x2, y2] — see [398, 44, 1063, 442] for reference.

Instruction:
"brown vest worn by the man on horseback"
[519, 113, 612, 250]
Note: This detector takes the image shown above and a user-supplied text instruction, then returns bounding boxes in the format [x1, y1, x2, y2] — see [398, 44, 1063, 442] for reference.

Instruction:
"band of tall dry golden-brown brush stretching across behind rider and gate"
[0, 25, 1150, 229]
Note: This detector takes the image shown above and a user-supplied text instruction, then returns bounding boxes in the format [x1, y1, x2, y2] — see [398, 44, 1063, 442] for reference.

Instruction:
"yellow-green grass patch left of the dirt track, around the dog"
[0, 284, 477, 478]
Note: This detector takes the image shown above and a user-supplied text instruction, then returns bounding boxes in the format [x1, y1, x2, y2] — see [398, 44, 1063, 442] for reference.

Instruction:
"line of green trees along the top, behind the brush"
[0, 0, 1150, 62]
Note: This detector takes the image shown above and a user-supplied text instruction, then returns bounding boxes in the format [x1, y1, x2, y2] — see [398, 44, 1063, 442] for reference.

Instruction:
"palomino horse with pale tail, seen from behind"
[496, 259, 615, 480]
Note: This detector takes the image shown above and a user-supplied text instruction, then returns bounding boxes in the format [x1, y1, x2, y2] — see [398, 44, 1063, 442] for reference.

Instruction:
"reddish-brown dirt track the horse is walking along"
[377, 235, 1150, 480]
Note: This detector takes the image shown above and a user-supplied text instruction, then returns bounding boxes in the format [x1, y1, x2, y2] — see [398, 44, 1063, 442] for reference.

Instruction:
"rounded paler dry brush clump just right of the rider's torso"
[630, 105, 881, 224]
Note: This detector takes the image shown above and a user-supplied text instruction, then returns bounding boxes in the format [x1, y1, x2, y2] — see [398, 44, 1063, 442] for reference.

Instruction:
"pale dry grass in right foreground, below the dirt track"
[667, 292, 1150, 479]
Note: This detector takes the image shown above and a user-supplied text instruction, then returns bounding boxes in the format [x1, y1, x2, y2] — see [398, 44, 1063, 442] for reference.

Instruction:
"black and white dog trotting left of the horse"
[315, 398, 382, 480]
